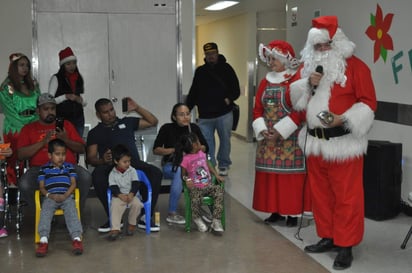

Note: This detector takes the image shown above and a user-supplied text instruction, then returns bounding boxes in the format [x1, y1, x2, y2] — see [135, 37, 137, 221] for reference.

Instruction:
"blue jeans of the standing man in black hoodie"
[198, 111, 233, 168]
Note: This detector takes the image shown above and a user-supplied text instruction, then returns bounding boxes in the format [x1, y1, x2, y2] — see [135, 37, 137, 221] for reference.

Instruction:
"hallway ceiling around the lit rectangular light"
[196, 0, 286, 25]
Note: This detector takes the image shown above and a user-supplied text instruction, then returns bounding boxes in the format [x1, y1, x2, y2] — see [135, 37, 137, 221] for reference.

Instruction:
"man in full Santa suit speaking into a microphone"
[278, 16, 377, 270]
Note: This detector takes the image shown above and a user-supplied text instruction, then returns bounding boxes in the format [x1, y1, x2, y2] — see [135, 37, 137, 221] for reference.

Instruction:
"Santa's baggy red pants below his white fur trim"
[307, 156, 364, 247]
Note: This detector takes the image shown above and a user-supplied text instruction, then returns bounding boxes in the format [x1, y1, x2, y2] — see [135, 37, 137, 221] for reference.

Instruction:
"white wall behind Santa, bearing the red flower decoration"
[287, 0, 412, 199]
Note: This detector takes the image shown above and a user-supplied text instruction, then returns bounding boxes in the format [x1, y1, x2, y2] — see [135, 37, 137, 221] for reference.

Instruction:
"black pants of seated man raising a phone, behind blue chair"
[92, 161, 163, 216]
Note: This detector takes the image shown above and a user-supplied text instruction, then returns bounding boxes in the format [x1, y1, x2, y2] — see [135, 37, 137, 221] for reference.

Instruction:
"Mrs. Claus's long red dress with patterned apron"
[253, 71, 311, 216]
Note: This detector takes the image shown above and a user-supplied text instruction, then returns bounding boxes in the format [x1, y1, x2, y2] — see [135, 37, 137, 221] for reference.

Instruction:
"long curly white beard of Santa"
[302, 49, 346, 86]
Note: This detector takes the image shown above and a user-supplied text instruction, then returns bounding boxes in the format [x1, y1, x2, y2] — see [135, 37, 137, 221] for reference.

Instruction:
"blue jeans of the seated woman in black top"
[163, 162, 183, 213]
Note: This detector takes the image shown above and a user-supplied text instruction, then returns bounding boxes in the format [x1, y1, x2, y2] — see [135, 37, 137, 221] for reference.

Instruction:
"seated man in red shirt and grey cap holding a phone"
[17, 93, 92, 212]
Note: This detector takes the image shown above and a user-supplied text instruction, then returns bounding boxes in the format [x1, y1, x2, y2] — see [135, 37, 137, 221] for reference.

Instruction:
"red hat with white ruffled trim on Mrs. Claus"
[259, 40, 298, 68]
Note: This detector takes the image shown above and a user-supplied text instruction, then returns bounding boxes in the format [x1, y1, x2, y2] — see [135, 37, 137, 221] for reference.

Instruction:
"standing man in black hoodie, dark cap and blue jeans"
[186, 42, 240, 175]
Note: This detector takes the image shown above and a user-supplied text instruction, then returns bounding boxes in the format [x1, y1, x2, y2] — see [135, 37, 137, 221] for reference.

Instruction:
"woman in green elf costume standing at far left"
[0, 53, 40, 185]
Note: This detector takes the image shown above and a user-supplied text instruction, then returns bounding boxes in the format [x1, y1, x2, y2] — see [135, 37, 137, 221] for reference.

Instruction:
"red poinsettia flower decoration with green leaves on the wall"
[365, 5, 393, 63]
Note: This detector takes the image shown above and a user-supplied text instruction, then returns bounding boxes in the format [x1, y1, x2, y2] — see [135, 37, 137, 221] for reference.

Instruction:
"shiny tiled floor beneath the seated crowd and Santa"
[0, 138, 412, 273]
